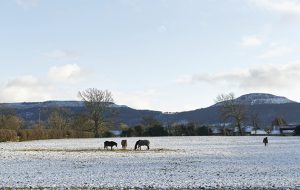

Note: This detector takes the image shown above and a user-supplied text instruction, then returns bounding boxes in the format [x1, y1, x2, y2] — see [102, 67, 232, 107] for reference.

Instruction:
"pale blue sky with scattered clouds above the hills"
[0, 0, 300, 111]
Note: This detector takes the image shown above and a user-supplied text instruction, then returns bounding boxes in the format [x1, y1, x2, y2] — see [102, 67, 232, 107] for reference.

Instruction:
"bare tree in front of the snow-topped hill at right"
[216, 93, 246, 135]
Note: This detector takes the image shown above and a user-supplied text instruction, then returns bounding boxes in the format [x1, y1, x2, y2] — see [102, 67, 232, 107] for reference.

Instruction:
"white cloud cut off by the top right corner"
[250, 0, 300, 15]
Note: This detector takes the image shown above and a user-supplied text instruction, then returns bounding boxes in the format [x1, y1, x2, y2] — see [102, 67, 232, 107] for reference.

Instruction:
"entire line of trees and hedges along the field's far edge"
[0, 88, 300, 141]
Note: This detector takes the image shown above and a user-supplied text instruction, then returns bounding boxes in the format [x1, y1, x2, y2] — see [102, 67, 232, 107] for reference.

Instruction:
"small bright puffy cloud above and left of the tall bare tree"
[48, 64, 84, 82]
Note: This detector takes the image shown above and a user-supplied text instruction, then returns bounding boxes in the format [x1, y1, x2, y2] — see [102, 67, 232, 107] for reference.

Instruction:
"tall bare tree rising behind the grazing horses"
[78, 88, 113, 137]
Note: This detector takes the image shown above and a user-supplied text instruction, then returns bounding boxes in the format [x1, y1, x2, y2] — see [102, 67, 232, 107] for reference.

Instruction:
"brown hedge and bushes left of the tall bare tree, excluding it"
[0, 107, 94, 142]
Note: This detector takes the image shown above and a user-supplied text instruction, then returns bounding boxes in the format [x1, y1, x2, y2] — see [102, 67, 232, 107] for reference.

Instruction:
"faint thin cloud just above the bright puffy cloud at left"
[44, 49, 80, 61]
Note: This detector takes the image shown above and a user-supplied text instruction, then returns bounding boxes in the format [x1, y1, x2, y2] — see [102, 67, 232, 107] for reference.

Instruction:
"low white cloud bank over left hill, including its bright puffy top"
[0, 64, 89, 102]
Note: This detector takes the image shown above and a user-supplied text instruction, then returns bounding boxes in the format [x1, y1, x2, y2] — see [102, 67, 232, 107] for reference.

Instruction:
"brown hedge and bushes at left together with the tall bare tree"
[0, 88, 113, 142]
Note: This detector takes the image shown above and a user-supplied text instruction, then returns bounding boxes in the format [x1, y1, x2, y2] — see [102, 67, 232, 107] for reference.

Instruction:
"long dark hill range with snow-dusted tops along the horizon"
[1, 93, 300, 126]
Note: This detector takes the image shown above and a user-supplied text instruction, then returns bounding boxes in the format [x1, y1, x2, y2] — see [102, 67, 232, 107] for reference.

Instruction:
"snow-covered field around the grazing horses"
[0, 137, 300, 189]
